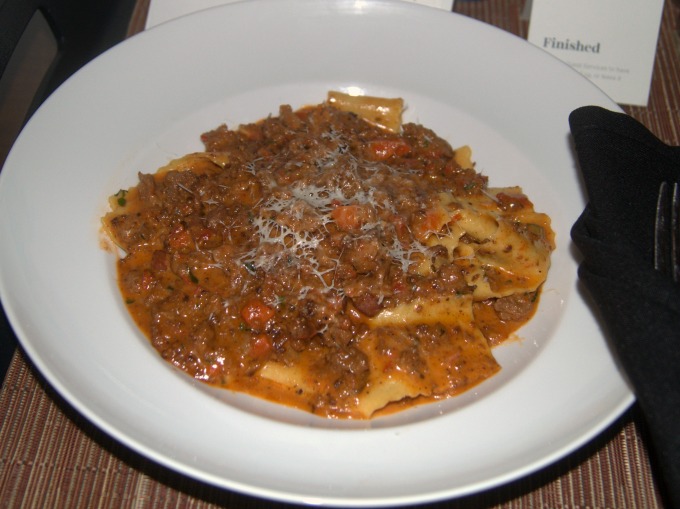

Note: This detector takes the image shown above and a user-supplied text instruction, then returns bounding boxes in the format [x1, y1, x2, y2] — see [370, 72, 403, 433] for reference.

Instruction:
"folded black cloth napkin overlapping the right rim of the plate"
[569, 106, 680, 508]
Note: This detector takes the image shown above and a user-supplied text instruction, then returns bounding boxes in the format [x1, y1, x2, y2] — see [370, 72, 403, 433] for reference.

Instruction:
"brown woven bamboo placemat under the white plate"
[0, 0, 680, 509]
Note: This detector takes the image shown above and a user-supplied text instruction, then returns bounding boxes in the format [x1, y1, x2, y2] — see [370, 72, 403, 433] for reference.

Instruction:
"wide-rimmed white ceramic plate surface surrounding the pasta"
[0, 0, 633, 506]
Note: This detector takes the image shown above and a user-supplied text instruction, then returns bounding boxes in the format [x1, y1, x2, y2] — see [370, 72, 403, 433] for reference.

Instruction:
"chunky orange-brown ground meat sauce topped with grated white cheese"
[104, 98, 552, 418]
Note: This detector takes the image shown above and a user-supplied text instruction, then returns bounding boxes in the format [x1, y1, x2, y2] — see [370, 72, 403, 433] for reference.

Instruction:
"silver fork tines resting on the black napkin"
[654, 182, 680, 283]
